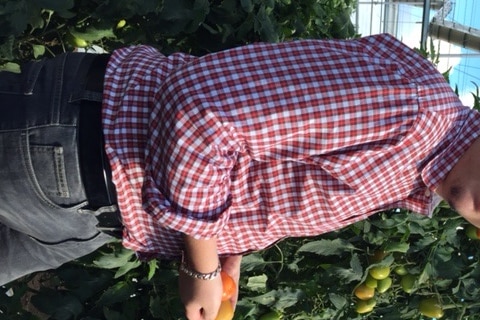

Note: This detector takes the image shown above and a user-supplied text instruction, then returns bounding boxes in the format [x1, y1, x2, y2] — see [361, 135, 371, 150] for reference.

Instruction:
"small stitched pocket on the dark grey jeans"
[30, 145, 70, 199]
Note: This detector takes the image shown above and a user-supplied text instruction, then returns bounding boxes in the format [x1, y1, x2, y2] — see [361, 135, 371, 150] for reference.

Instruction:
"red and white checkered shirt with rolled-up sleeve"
[103, 35, 480, 258]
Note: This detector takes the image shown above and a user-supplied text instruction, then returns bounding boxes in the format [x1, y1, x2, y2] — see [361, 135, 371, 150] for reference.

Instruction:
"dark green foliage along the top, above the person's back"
[0, 0, 354, 64]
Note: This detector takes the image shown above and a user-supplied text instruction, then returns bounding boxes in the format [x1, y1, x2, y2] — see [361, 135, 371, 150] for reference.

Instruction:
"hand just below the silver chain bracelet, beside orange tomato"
[179, 272, 223, 320]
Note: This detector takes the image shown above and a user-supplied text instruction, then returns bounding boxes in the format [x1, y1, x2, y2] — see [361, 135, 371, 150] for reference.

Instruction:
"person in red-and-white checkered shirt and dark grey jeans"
[0, 34, 480, 319]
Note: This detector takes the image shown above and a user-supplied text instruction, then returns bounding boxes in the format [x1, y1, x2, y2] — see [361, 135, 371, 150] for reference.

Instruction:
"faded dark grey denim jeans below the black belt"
[0, 53, 112, 285]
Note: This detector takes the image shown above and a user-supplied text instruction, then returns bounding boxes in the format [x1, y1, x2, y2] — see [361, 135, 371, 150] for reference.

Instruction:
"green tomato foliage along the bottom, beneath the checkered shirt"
[4, 207, 480, 320]
